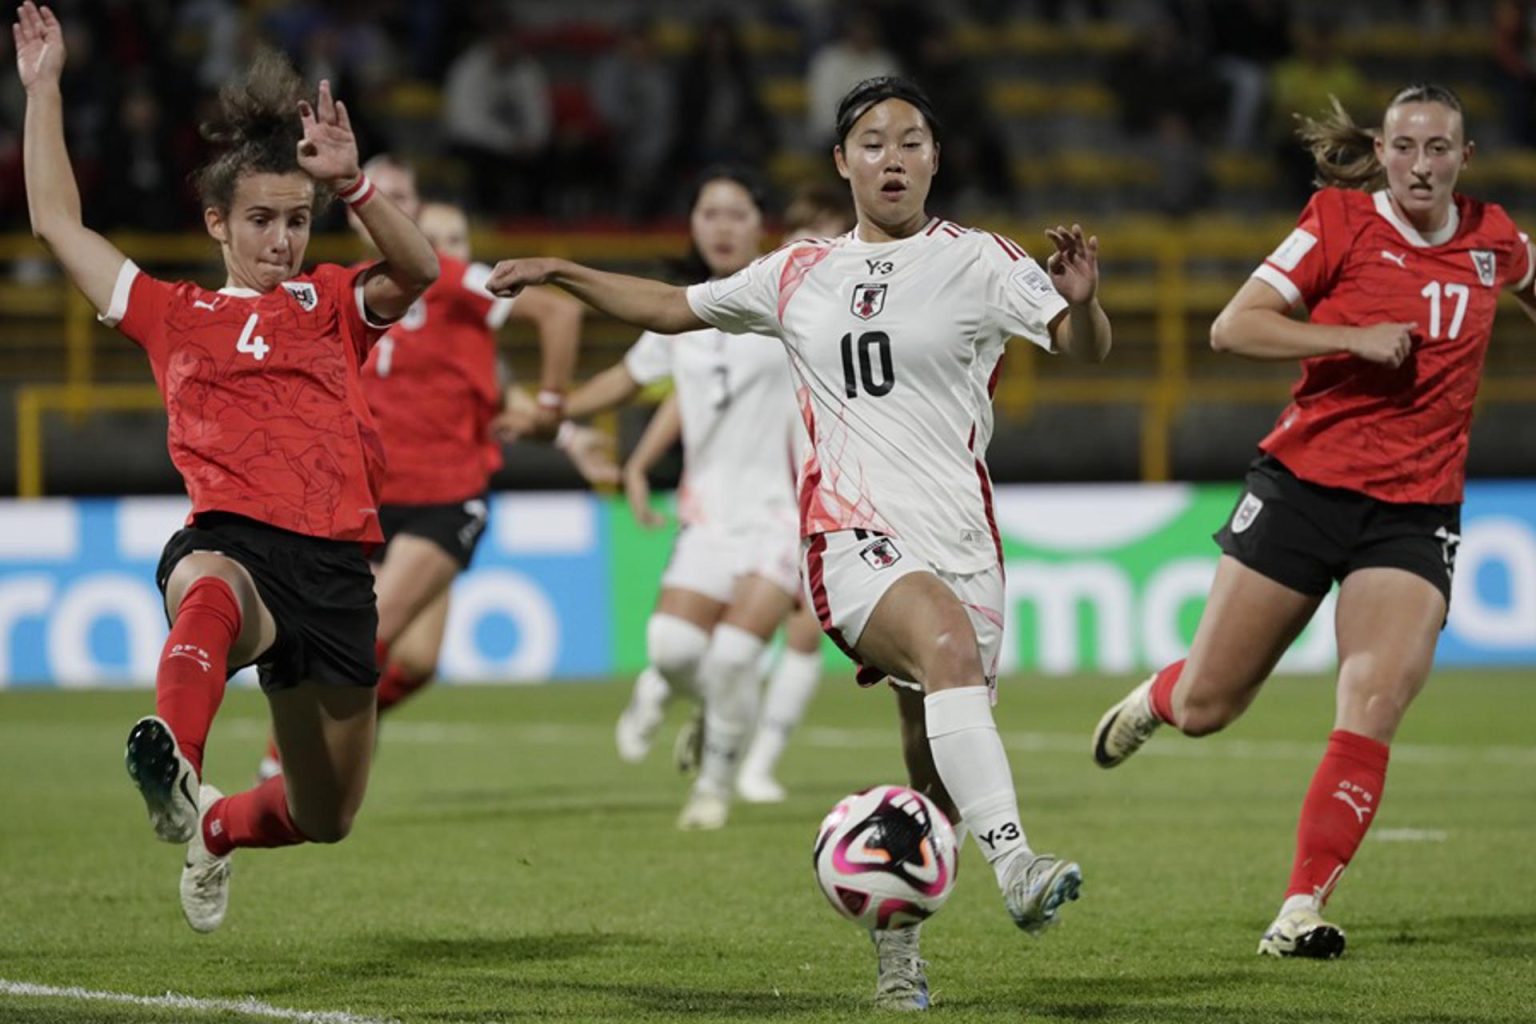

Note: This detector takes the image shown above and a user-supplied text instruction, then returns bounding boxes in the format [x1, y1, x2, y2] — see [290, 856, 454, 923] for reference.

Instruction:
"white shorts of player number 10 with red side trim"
[803, 530, 1003, 688]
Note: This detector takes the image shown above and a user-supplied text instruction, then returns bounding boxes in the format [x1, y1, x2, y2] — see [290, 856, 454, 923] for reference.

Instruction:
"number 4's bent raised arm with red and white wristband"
[298, 81, 438, 319]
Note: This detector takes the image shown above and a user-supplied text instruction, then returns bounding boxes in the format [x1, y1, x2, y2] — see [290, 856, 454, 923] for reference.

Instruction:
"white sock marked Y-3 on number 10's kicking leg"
[923, 686, 1029, 884]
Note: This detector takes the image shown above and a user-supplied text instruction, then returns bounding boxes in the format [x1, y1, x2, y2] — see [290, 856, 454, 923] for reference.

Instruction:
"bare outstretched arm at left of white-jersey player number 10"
[485, 258, 708, 335]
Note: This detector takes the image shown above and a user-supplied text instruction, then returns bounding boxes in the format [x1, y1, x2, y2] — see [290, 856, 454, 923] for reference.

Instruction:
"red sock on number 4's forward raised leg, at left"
[155, 576, 240, 777]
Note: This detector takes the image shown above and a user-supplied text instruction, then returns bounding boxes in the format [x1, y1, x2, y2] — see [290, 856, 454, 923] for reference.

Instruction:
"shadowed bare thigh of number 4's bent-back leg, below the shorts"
[267, 683, 376, 838]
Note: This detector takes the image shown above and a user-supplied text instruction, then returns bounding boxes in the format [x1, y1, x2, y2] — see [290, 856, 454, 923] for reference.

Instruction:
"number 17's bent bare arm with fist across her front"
[1210, 278, 1418, 367]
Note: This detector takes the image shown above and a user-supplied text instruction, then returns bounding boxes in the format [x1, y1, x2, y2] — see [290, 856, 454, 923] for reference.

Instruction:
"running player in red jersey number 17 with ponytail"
[1094, 84, 1536, 958]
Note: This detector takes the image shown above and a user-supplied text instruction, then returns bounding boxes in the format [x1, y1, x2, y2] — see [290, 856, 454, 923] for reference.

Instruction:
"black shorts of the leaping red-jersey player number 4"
[155, 513, 379, 692]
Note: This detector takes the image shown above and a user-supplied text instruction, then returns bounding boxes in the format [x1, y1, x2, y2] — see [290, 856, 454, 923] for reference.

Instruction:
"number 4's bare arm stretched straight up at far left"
[11, 0, 127, 312]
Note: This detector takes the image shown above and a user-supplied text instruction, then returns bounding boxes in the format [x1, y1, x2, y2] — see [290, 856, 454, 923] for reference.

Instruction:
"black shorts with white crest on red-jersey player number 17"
[1215, 454, 1461, 608]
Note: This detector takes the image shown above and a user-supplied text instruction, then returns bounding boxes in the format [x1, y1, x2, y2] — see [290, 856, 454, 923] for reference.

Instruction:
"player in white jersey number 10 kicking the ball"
[487, 78, 1111, 1009]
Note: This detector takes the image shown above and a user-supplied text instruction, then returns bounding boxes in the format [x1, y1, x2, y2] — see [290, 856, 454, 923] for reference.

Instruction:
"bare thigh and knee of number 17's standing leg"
[1335, 568, 1445, 743]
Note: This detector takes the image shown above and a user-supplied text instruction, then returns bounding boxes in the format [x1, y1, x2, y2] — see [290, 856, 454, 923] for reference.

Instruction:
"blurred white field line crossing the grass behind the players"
[218, 718, 1536, 765]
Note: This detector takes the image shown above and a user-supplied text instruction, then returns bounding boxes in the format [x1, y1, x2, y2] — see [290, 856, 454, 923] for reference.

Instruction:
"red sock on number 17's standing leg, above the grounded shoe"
[1286, 729, 1390, 903]
